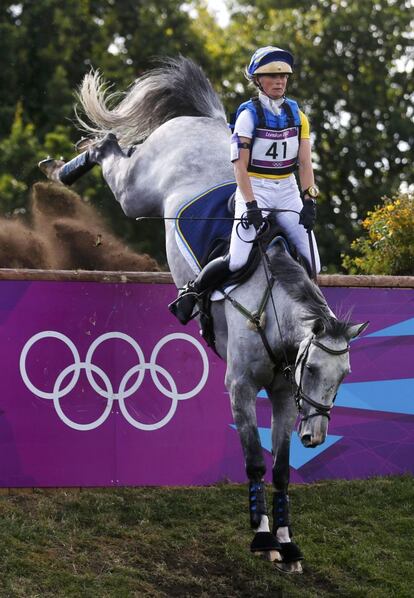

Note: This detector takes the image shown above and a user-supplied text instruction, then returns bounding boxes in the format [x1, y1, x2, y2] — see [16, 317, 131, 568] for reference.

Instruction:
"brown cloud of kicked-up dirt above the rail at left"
[0, 183, 160, 272]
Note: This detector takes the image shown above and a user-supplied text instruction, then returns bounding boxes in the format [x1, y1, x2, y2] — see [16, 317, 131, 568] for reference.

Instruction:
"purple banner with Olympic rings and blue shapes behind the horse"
[0, 280, 414, 487]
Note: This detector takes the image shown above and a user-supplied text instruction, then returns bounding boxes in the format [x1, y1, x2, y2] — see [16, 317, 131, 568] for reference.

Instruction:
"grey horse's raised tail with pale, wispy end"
[75, 56, 226, 145]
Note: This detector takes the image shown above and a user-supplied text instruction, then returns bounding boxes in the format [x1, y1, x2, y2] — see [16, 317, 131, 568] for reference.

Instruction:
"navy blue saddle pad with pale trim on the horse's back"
[175, 181, 236, 269]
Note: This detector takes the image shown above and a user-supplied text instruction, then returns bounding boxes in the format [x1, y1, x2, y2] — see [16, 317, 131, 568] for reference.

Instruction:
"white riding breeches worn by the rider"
[229, 174, 321, 272]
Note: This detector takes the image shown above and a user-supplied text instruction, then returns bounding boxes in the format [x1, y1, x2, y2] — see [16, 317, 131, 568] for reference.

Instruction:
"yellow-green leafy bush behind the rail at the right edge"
[342, 194, 414, 276]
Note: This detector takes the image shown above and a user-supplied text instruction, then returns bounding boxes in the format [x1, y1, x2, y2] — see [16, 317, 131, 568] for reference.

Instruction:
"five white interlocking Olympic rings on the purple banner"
[19, 330, 209, 431]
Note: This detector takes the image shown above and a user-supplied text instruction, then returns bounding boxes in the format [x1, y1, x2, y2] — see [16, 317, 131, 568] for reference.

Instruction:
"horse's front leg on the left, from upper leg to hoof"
[227, 376, 279, 560]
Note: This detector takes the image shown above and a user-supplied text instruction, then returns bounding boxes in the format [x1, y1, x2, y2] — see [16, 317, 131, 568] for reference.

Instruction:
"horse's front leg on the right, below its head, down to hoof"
[268, 374, 303, 573]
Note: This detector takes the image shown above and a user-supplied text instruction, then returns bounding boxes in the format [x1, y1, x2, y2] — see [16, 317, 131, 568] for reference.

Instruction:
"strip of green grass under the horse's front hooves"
[0, 476, 414, 598]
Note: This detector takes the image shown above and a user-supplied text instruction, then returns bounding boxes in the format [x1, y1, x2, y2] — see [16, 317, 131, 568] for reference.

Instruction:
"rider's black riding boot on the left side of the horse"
[168, 256, 230, 324]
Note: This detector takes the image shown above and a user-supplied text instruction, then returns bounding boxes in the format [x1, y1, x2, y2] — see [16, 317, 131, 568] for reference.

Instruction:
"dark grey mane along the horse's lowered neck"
[270, 244, 349, 338]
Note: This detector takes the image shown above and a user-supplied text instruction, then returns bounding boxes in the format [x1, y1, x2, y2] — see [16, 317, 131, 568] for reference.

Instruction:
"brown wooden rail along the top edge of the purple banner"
[0, 268, 414, 289]
